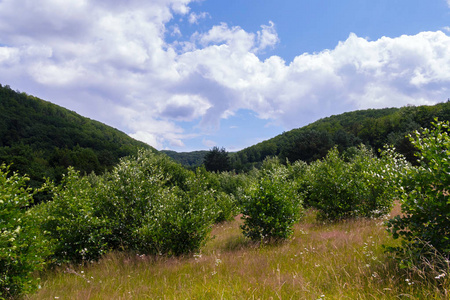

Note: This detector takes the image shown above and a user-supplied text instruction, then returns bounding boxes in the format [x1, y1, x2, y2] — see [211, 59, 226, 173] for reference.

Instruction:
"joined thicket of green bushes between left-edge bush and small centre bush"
[36, 150, 217, 262]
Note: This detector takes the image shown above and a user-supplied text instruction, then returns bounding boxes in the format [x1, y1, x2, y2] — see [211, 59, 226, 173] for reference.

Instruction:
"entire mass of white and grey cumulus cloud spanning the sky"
[0, 0, 450, 149]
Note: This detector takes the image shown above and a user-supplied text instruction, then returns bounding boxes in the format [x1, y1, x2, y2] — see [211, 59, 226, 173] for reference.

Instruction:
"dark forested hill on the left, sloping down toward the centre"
[0, 85, 156, 186]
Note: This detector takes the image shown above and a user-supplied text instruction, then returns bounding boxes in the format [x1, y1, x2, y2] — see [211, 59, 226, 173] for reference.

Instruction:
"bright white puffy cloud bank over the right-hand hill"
[178, 29, 450, 128]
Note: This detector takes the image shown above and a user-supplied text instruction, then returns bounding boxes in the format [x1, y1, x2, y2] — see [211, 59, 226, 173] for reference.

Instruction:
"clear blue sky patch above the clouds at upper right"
[186, 0, 450, 61]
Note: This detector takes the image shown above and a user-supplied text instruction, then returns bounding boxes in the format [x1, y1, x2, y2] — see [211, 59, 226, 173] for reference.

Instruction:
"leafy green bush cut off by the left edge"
[0, 164, 50, 298]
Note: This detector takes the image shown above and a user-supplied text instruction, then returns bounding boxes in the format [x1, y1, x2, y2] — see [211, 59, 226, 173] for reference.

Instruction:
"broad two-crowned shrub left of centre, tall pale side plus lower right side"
[99, 151, 215, 255]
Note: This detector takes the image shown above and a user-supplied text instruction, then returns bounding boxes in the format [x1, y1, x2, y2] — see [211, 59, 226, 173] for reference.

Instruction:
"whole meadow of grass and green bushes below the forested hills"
[0, 122, 450, 299]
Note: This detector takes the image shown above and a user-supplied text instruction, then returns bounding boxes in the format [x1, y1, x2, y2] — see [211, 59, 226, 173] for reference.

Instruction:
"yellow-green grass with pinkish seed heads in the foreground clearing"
[29, 211, 450, 299]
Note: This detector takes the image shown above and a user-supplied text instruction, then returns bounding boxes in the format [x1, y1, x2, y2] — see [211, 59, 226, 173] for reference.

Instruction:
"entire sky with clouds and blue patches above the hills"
[0, 0, 450, 151]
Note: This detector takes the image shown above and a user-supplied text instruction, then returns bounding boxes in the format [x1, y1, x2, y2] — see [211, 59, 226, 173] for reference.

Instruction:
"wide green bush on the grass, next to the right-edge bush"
[302, 145, 399, 220]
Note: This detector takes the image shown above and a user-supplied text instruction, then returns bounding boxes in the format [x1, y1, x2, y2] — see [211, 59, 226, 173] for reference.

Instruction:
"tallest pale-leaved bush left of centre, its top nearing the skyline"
[97, 151, 168, 250]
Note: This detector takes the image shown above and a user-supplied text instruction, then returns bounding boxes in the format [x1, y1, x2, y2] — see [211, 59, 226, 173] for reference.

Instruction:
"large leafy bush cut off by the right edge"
[387, 119, 450, 261]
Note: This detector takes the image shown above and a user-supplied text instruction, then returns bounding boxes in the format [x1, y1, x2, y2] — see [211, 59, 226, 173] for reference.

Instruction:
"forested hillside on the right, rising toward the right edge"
[231, 101, 450, 171]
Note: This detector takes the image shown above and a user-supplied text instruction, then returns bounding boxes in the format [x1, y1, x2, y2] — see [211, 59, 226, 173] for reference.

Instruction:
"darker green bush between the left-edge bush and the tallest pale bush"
[34, 168, 109, 263]
